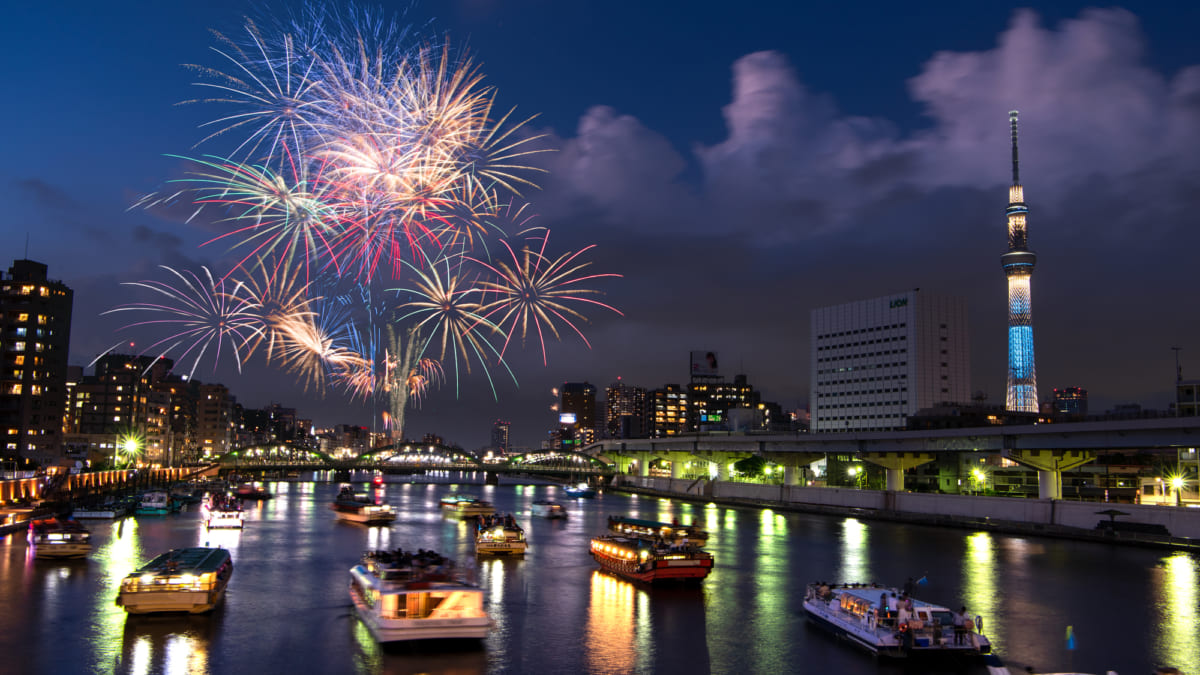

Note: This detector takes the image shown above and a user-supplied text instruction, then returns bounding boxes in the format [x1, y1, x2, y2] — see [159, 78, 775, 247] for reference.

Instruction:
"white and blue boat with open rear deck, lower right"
[804, 583, 991, 658]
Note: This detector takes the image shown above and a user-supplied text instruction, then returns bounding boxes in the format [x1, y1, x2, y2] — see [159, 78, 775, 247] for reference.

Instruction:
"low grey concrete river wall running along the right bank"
[613, 476, 1200, 539]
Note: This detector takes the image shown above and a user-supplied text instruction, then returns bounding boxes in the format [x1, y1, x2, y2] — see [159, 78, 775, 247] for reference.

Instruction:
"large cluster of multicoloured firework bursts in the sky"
[112, 5, 619, 440]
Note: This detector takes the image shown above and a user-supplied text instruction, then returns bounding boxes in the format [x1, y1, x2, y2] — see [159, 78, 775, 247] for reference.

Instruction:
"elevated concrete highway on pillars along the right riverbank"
[582, 417, 1200, 500]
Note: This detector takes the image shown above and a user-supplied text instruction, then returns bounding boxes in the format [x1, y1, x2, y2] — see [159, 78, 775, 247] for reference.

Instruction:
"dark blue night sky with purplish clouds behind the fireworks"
[0, 0, 1200, 448]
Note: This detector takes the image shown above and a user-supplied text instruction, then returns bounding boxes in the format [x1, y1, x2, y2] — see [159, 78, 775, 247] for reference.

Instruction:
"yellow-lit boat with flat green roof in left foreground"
[116, 546, 233, 614]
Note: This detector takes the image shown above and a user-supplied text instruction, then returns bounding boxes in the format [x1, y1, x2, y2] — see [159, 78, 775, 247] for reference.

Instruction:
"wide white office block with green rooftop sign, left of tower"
[810, 289, 971, 432]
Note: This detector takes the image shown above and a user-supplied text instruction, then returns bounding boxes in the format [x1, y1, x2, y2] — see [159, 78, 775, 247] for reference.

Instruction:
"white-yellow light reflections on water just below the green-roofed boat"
[113, 609, 224, 675]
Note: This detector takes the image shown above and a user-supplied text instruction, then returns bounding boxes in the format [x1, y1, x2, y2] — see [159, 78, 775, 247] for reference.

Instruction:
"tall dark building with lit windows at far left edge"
[0, 259, 74, 464]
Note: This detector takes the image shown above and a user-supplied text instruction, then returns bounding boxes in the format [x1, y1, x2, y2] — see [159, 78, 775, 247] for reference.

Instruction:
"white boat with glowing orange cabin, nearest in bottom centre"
[350, 549, 491, 644]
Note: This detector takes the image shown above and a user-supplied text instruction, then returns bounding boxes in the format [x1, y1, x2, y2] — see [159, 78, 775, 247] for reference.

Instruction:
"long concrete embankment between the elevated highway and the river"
[612, 476, 1200, 550]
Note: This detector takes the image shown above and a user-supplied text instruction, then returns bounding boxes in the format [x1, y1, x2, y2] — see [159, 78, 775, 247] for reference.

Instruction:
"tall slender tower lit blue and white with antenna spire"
[1000, 110, 1038, 412]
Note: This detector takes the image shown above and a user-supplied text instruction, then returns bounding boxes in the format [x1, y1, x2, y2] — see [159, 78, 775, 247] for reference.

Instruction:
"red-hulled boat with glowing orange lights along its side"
[590, 534, 713, 584]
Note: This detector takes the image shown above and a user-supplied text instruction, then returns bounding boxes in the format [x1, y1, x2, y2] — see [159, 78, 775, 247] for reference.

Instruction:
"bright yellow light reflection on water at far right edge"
[1154, 554, 1200, 673]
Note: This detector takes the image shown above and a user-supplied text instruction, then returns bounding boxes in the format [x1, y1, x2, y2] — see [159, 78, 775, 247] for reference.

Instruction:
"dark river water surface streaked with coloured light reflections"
[0, 477, 1200, 675]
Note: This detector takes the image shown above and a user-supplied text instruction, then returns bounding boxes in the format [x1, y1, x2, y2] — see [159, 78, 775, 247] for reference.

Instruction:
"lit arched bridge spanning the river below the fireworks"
[210, 443, 614, 479]
